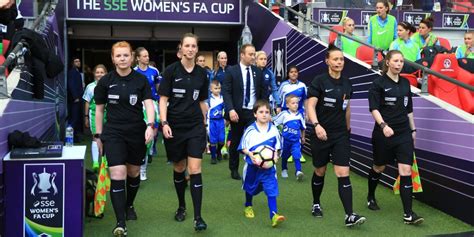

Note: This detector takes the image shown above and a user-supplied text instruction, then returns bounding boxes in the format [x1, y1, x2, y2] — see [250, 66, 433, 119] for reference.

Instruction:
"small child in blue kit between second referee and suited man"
[207, 80, 225, 164]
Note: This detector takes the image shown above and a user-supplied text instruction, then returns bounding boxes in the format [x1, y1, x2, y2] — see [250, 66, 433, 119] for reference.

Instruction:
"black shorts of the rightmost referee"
[372, 129, 414, 166]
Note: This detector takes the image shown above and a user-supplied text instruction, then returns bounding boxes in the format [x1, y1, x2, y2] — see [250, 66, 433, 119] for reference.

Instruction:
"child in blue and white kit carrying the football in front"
[238, 100, 285, 227]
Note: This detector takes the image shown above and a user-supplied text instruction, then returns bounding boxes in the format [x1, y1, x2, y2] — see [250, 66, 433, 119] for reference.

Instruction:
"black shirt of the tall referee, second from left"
[158, 61, 209, 128]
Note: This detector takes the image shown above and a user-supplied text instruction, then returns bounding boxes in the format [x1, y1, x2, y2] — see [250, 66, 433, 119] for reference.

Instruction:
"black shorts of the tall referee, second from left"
[164, 124, 206, 163]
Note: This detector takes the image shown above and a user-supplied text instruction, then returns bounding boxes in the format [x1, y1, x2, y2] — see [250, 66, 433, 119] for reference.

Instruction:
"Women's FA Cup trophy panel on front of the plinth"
[23, 164, 65, 237]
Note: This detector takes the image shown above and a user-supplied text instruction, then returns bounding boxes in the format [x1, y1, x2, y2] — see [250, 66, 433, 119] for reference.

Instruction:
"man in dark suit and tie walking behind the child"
[222, 44, 268, 180]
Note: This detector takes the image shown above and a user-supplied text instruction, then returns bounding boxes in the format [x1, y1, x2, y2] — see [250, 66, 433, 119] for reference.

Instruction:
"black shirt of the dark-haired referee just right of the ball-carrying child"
[308, 73, 352, 134]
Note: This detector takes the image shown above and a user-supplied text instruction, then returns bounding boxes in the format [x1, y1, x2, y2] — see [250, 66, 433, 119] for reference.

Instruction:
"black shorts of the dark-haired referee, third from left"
[311, 132, 351, 168]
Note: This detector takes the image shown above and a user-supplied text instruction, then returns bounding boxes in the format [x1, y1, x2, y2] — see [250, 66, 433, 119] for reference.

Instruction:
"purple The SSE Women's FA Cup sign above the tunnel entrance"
[67, 0, 242, 24]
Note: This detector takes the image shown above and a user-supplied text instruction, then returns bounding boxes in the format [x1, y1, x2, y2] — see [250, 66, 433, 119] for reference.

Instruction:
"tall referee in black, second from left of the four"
[158, 33, 209, 231]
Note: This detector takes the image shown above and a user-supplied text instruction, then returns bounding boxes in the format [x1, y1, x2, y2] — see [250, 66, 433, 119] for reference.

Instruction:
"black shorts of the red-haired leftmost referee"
[101, 123, 146, 167]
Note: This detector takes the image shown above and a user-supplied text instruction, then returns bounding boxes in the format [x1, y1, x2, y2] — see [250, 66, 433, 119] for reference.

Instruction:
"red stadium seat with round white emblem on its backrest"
[428, 54, 463, 109]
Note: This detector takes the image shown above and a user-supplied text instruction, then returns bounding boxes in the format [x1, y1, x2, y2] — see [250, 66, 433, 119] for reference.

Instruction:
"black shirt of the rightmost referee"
[369, 75, 413, 134]
